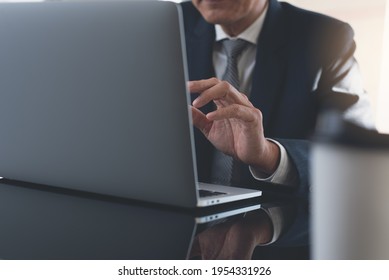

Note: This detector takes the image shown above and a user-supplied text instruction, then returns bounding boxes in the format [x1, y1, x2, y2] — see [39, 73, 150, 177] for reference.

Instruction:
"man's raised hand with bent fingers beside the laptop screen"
[188, 78, 280, 174]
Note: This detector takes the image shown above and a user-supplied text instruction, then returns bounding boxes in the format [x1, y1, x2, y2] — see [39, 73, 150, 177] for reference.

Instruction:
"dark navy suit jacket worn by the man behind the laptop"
[182, 0, 369, 246]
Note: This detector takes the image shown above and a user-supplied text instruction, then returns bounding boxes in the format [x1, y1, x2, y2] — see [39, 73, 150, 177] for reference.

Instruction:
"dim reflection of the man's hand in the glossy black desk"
[190, 210, 273, 260]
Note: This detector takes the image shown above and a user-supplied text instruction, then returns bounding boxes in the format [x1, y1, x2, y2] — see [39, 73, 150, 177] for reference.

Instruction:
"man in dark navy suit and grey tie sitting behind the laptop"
[182, 0, 370, 258]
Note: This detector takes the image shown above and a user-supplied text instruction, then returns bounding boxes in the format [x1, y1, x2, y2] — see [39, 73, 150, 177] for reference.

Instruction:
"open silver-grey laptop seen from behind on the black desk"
[0, 1, 261, 207]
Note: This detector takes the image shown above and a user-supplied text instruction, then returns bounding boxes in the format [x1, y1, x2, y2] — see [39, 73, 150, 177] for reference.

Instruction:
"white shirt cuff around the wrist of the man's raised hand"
[249, 138, 298, 186]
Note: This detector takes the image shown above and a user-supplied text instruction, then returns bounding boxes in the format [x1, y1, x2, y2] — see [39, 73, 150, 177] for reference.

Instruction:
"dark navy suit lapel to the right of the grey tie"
[250, 0, 287, 131]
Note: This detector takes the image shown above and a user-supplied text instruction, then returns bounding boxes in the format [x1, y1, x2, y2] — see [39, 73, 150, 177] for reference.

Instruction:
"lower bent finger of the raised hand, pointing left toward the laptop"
[206, 104, 262, 122]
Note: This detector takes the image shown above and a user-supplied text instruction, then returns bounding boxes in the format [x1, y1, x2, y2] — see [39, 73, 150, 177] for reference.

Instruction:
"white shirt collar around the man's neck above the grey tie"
[215, 4, 269, 45]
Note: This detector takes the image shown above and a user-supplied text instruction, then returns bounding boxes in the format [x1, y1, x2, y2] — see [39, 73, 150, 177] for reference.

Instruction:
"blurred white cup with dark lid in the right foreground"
[311, 115, 389, 259]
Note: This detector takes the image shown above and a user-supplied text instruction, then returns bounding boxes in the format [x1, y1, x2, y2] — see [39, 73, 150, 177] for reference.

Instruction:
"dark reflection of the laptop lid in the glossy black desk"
[0, 180, 259, 260]
